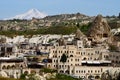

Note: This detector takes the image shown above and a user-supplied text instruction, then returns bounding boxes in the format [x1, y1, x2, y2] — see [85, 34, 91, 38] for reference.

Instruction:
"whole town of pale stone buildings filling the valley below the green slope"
[0, 27, 120, 80]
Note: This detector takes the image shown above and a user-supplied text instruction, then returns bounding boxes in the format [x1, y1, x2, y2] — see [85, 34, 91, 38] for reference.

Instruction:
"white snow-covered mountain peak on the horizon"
[4, 9, 47, 20]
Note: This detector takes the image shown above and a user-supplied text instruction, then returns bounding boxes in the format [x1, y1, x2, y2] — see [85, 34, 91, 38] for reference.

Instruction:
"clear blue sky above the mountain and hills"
[0, 0, 120, 19]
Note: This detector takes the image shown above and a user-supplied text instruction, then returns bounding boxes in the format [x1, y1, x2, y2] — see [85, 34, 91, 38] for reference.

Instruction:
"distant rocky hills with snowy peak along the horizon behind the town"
[0, 9, 120, 33]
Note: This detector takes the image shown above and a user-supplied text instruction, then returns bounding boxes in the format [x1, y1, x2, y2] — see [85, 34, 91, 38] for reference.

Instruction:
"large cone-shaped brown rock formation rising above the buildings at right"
[88, 15, 111, 42]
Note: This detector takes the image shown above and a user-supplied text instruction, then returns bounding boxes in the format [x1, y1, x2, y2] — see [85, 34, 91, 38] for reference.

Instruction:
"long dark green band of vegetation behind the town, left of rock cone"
[0, 26, 77, 37]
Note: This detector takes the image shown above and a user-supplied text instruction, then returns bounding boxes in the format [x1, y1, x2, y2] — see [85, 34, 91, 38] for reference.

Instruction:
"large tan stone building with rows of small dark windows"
[47, 45, 120, 79]
